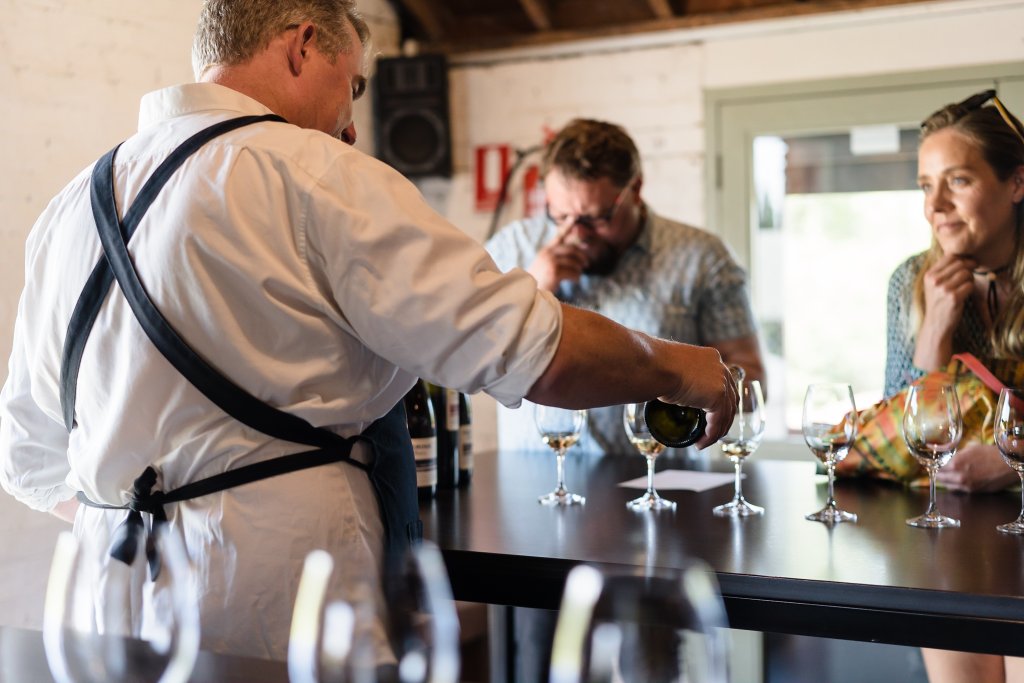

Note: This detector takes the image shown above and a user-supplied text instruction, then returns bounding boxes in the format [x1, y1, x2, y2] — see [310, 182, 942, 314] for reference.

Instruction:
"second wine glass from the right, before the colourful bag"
[903, 381, 964, 528]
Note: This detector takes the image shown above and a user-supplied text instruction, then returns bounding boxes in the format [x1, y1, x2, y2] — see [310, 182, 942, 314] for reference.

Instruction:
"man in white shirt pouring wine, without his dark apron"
[0, 0, 734, 659]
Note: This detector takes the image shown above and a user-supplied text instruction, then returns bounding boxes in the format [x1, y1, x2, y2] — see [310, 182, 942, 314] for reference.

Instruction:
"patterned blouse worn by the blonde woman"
[885, 252, 992, 397]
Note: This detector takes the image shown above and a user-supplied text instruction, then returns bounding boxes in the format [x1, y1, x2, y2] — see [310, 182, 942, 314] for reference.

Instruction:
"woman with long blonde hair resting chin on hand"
[886, 90, 1024, 683]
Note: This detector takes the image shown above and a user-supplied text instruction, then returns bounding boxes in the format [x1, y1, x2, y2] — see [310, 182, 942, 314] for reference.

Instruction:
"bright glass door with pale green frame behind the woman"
[707, 66, 1024, 453]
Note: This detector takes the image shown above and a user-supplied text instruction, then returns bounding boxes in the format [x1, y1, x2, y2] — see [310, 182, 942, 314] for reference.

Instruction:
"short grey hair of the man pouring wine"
[193, 0, 370, 80]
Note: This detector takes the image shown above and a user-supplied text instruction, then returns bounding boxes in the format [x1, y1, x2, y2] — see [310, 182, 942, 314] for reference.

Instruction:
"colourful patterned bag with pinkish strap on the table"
[836, 353, 1024, 486]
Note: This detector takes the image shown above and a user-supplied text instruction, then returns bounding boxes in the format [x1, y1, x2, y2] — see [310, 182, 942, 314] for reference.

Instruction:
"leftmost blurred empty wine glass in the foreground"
[43, 524, 200, 683]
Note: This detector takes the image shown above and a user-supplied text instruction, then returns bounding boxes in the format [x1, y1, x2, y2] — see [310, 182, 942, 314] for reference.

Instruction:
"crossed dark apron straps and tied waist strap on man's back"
[69, 116, 380, 577]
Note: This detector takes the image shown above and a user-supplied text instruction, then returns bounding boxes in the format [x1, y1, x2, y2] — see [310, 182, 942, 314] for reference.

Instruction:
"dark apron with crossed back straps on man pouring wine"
[60, 115, 423, 578]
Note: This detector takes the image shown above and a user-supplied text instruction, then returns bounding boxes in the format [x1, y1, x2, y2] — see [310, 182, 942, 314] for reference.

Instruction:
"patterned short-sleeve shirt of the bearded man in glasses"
[486, 209, 756, 454]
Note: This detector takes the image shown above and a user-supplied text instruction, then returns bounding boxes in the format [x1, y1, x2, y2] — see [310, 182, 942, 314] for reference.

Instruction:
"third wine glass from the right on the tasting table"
[803, 384, 857, 524]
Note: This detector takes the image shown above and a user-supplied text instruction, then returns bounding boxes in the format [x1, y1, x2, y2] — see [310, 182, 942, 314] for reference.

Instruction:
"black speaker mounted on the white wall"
[374, 54, 452, 176]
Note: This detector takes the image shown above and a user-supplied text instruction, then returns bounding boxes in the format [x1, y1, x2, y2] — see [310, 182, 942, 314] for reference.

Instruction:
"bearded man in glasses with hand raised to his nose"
[486, 119, 764, 454]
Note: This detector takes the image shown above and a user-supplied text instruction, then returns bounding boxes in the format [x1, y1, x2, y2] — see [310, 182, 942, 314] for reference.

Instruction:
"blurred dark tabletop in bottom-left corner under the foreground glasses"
[0, 627, 288, 683]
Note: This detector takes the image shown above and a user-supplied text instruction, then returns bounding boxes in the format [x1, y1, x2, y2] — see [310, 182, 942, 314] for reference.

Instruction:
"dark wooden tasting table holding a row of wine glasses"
[422, 452, 1024, 655]
